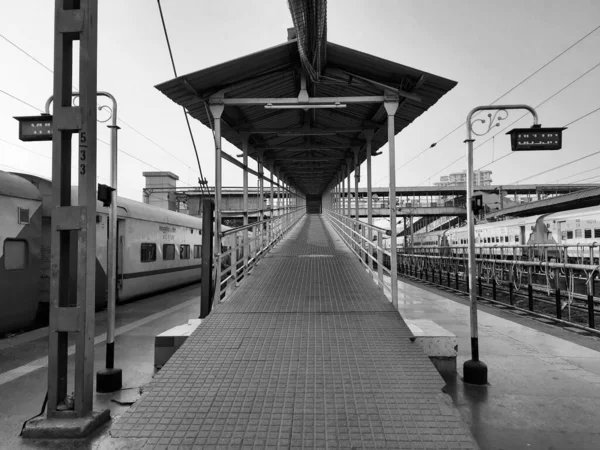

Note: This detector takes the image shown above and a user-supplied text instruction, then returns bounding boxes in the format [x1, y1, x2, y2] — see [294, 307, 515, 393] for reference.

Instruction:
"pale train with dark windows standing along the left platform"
[0, 171, 248, 333]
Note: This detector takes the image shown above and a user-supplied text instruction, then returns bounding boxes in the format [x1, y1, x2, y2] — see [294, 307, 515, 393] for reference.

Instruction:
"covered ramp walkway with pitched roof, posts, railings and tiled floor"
[120, 25, 477, 448]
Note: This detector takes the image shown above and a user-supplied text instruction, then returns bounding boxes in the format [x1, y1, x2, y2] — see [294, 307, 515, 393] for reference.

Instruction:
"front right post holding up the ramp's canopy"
[384, 100, 399, 308]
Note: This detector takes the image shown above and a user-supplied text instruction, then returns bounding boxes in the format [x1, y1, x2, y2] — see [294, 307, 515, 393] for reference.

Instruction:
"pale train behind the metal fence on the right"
[385, 206, 600, 264]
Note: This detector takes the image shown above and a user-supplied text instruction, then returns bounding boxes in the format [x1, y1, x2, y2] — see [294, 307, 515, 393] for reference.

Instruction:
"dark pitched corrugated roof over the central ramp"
[156, 39, 456, 195]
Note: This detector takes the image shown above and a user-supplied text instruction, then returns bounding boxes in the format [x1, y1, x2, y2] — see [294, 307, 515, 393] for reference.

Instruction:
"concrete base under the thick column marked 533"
[21, 409, 110, 439]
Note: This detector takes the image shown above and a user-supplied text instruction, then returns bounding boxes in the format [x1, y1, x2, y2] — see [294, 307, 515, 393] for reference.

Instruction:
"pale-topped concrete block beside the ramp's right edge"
[405, 319, 458, 375]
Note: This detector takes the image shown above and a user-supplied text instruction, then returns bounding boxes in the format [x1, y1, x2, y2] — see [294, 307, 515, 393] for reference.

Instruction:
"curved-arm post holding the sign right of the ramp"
[463, 105, 538, 385]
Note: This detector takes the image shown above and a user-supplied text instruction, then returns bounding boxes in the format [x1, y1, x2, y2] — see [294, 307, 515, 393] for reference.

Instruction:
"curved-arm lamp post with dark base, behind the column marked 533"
[45, 91, 123, 392]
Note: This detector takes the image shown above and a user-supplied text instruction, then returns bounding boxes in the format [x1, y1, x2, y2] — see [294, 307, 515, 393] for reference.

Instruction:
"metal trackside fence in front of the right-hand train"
[396, 243, 600, 331]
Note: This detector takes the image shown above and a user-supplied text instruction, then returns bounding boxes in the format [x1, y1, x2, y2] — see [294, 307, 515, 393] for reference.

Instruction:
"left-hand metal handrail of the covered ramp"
[213, 205, 306, 308]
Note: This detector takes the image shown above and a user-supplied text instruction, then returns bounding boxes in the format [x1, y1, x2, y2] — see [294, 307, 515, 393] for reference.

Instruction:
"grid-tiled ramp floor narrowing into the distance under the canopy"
[111, 216, 477, 449]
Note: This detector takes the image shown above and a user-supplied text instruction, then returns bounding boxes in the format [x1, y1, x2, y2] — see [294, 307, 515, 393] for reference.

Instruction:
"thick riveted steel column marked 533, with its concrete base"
[30, 0, 110, 438]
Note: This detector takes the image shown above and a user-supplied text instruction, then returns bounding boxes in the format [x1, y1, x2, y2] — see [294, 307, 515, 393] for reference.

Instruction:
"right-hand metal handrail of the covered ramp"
[325, 210, 398, 294]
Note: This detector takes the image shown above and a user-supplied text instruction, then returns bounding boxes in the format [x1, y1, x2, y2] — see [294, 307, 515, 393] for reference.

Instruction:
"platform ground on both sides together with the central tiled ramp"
[0, 216, 600, 450]
